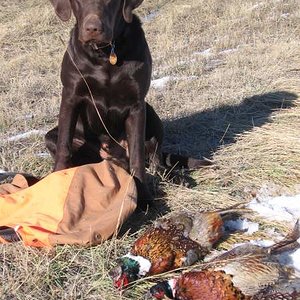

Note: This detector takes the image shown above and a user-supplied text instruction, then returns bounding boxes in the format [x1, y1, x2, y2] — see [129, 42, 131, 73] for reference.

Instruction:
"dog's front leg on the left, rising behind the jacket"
[54, 88, 78, 171]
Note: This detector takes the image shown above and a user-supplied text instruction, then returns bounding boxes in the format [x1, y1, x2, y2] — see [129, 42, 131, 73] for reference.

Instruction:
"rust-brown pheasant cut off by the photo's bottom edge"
[146, 221, 300, 300]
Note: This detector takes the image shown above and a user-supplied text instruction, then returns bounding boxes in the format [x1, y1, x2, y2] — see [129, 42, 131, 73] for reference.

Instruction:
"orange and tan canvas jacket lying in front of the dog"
[0, 161, 137, 247]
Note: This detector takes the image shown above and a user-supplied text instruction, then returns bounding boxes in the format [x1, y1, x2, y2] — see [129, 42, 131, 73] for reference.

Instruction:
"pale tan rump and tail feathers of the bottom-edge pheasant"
[210, 222, 300, 296]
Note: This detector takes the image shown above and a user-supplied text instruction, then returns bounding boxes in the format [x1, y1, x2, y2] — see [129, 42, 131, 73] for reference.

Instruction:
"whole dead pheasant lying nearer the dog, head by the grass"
[110, 205, 245, 288]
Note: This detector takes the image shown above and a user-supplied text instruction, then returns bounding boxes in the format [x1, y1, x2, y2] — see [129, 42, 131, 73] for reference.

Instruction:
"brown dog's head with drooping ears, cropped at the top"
[50, 0, 143, 44]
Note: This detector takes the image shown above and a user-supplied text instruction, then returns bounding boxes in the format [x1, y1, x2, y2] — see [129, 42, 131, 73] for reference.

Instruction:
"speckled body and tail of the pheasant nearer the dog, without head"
[130, 207, 243, 275]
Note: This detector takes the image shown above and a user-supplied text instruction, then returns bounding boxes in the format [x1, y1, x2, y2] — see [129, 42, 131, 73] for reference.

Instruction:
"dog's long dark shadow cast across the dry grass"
[163, 91, 298, 158]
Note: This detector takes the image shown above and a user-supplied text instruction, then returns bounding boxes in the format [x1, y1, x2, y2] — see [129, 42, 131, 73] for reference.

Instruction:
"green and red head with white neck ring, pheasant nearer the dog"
[109, 254, 151, 289]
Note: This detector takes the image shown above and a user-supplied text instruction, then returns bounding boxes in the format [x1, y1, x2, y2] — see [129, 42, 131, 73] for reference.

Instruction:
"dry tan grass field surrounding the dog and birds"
[0, 0, 300, 300]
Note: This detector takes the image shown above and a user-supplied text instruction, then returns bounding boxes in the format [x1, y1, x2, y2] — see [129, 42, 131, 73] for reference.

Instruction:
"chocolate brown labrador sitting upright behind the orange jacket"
[46, 0, 163, 205]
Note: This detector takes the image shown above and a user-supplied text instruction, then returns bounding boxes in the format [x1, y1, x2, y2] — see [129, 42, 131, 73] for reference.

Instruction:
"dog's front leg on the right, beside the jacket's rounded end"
[126, 102, 151, 209]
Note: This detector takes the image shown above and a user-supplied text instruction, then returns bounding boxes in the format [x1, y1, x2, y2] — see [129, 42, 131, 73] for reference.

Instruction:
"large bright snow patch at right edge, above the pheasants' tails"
[248, 194, 300, 223]
